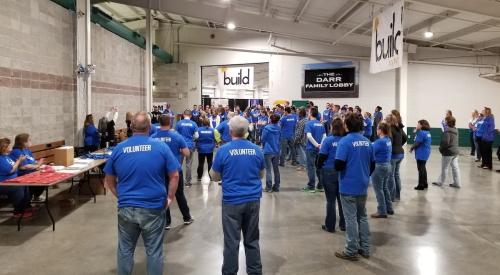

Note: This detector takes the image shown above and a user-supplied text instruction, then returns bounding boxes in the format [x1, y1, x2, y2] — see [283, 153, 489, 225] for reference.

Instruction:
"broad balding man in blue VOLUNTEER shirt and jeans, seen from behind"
[104, 112, 179, 274]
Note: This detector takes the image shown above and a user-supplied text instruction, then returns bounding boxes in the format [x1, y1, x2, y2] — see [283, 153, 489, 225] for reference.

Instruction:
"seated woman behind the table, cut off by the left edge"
[0, 138, 33, 218]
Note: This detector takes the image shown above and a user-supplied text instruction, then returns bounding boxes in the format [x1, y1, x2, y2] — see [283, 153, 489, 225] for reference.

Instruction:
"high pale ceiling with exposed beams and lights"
[94, 0, 500, 53]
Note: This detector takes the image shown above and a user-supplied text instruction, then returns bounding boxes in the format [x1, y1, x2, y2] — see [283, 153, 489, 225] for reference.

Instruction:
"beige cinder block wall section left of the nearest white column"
[0, 0, 75, 144]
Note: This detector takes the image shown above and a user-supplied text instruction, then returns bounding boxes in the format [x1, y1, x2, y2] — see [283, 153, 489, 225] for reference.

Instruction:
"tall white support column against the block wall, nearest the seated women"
[74, 0, 92, 146]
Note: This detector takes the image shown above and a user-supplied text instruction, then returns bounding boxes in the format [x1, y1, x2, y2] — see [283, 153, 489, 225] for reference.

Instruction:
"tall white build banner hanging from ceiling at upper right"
[370, 1, 404, 74]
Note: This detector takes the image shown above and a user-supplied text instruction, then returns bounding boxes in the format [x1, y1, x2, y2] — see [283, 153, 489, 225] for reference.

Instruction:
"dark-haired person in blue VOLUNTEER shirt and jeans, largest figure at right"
[335, 113, 375, 260]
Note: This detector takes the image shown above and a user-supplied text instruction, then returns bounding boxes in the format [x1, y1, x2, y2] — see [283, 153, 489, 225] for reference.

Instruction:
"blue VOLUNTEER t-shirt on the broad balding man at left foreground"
[104, 135, 180, 209]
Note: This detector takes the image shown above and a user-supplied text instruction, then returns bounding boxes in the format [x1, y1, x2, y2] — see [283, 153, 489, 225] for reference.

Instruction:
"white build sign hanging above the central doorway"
[218, 67, 254, 90]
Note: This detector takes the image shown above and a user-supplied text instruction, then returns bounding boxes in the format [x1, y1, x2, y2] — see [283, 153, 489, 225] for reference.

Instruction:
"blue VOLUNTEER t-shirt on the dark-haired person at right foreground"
[335, 133, 374, 196]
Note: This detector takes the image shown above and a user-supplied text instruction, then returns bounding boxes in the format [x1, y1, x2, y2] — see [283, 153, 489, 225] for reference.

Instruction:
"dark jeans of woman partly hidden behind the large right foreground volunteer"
[321, 168, 345, 231]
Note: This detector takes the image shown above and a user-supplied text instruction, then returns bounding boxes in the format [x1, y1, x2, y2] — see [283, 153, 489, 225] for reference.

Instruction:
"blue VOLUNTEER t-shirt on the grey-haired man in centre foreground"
[212, 139, 265, 204]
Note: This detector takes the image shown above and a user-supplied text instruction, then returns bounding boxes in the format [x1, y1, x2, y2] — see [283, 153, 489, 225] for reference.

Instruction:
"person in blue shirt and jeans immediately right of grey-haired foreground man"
[262, 115, 281, 192]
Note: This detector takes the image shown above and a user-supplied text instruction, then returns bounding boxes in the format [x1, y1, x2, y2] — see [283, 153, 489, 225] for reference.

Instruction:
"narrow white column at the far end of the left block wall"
[144, 5, 154, 112]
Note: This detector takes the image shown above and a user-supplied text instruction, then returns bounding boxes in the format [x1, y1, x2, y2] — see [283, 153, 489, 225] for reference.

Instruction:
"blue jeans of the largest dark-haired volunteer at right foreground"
[340, 195, 370, 256]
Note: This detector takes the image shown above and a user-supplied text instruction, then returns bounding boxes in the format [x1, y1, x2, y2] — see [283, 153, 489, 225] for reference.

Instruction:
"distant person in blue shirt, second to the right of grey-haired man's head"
[279, 107, 297, 167]
